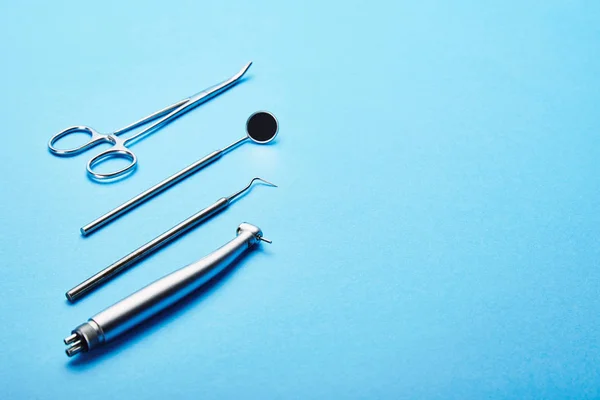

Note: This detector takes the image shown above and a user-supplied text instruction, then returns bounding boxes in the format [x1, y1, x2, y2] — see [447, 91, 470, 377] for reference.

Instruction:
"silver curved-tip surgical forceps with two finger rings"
[48, 62, 252, 179]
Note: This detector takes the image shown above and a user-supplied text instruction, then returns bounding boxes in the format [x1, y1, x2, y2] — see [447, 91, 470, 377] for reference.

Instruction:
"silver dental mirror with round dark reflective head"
[79, 111, 279, 236]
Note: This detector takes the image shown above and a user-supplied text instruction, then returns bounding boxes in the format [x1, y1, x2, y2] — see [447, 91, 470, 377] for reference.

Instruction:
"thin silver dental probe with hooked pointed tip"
[65, 177, 277, 302]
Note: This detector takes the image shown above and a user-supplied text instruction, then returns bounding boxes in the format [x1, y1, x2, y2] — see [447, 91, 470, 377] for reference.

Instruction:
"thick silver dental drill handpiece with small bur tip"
[64, 223, 271, 357]
